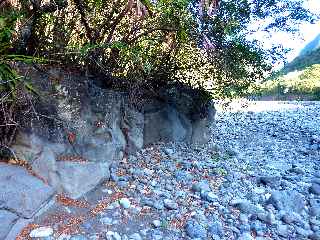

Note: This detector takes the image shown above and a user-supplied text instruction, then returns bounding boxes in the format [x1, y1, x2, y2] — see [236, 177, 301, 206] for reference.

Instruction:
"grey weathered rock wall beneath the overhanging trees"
[8, 65, 214, 198]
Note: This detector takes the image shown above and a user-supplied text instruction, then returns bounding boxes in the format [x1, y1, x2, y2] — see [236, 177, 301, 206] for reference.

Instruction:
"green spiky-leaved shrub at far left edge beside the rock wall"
[0, 11, 36, 146]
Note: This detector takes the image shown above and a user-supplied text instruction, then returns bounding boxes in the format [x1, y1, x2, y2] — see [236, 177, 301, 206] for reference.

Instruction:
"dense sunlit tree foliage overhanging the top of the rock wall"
[1, 0, 315, 96]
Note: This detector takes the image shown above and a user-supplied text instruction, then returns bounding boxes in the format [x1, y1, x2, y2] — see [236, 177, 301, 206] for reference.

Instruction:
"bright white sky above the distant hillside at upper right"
[252, 0, 320, 62]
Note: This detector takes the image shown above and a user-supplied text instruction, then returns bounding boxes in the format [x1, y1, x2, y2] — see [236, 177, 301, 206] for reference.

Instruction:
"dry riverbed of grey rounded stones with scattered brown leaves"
[11, 102, 320, 240]
